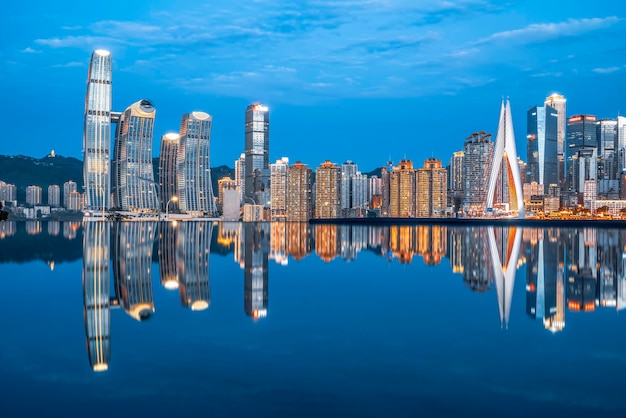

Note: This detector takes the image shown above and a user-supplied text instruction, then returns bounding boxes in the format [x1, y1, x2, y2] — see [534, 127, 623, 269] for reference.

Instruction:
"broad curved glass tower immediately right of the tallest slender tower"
[113, 100, 159, 212]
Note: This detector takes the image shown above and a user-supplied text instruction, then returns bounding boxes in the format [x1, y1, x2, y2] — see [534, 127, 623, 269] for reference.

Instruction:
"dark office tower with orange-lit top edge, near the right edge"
[565, 115, 598, 193]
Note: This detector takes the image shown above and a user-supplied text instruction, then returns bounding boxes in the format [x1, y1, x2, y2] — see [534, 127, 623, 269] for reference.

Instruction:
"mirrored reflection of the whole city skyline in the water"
[0, 222, 626, 370]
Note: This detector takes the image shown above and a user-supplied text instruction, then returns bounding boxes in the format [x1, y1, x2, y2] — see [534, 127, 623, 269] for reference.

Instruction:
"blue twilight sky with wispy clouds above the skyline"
[0, 0, 626, 171]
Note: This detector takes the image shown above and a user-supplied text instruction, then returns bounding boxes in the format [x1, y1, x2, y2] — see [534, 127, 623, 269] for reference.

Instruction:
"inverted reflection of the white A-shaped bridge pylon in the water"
[487, 226, 522, 329]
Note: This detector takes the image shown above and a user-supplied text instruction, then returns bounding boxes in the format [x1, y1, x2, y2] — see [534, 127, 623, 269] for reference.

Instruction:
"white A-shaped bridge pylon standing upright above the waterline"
[486, 100, 524, 218]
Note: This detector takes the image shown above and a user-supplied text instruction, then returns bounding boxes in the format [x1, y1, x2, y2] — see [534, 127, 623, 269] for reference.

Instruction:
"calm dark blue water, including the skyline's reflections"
[0, 222, 626, 417]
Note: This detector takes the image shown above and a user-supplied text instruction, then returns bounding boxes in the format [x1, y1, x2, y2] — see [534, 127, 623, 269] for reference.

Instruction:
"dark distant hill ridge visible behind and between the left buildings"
[0, 155, 235, 203]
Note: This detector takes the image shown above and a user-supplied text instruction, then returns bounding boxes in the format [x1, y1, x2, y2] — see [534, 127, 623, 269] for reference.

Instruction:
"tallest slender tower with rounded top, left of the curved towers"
[83, 49, 112, 210]
